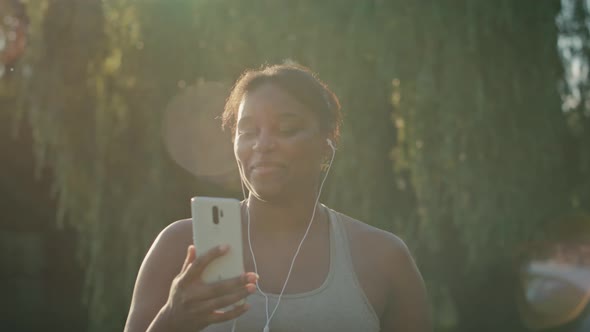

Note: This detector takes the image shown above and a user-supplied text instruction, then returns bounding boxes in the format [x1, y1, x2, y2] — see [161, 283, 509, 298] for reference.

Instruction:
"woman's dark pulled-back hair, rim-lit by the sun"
[221, 64, 342, 143]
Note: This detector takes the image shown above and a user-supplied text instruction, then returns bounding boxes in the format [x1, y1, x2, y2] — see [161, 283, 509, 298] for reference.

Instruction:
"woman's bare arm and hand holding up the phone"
[125, 220, 258, 332]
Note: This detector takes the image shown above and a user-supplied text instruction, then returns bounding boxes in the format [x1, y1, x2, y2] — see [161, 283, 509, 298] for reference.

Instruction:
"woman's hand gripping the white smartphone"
[162, 245, 258, 332]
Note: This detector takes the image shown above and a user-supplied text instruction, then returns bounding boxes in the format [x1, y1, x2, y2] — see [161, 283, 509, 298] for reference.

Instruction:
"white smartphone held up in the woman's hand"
[191, 196, 244, 282]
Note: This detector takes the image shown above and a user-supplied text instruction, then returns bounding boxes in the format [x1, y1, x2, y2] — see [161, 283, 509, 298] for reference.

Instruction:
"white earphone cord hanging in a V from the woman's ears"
[232, 139, 336, 332]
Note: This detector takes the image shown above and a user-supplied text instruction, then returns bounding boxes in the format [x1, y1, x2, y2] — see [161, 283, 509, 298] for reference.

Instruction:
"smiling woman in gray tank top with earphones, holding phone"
[125, 65, 431, 332]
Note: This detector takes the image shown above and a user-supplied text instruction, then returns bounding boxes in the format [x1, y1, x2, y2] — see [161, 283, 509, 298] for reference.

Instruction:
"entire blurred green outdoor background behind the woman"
[0, 0, 590, 332]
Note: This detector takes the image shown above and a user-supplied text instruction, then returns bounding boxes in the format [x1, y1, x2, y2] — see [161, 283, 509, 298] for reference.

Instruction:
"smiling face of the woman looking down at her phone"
[234, 83, 326, 201]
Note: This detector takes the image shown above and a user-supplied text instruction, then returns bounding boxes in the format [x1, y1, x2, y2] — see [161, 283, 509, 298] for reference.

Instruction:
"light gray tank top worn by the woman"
[204, 209, 380, 332]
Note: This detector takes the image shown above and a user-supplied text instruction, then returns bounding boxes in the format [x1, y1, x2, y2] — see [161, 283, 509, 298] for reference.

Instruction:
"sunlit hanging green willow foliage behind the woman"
[6, 0, 588, 331]
